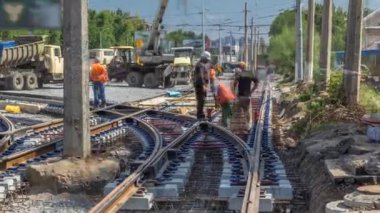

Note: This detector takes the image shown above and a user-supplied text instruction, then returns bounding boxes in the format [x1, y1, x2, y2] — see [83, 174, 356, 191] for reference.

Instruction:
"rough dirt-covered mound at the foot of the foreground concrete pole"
[25, 159, 119, 194]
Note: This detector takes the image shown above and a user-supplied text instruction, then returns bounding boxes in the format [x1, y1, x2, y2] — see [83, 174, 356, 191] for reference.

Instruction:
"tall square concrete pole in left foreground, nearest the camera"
[63, 0, 91, 158]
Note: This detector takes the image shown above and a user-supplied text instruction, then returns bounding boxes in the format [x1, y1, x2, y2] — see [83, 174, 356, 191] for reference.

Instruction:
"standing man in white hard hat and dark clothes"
[194, 51, 211, 120]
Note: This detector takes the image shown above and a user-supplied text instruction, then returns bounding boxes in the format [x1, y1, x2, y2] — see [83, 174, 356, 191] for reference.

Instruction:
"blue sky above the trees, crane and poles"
[89, 0, 380, 38]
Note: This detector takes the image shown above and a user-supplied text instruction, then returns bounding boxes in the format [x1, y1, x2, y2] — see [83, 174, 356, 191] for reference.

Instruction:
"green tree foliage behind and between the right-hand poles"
[268, 4, 347, 81]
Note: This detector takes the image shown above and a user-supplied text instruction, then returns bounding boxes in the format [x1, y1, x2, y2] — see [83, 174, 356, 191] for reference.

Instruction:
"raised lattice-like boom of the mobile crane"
[146, 0, 169, 55]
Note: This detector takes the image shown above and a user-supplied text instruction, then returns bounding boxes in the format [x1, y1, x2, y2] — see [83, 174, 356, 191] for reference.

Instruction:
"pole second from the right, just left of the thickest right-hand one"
[319, 0, 332, 91]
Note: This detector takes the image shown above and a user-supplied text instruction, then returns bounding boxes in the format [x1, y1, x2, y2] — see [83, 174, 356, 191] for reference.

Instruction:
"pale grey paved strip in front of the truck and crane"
[2, 83, 190, 103]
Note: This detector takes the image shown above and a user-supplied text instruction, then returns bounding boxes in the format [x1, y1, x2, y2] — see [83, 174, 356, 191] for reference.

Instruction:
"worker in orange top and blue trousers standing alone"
[90, 58, 108, 107]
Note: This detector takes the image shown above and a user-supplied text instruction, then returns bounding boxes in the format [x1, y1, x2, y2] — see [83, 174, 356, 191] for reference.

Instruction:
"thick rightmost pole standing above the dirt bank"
[344, 0, 363, 105]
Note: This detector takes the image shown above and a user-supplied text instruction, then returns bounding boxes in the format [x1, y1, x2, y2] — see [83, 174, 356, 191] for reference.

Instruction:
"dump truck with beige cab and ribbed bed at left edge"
[0, 36, 63, 90]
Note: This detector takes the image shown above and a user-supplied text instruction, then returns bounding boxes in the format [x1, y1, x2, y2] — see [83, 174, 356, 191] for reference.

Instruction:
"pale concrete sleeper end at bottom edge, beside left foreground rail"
[120, 193, 154, 210]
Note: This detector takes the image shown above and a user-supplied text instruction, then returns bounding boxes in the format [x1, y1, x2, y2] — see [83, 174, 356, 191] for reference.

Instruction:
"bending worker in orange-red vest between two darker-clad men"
[216, 83, 235, 127]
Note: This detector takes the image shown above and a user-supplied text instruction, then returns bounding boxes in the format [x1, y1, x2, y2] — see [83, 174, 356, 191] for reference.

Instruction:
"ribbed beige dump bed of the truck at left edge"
[0, 36, 45, 67]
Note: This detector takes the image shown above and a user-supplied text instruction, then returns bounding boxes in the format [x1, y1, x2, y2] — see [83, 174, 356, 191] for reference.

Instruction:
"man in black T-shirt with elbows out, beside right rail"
[234, 62, 259, 130]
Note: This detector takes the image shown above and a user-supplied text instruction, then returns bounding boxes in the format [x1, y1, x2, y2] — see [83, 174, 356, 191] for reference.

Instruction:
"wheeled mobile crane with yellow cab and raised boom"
[108, 0, 176, 88]
